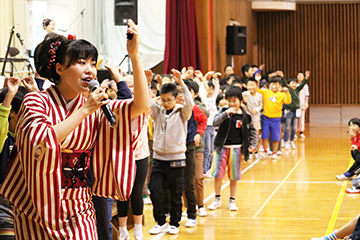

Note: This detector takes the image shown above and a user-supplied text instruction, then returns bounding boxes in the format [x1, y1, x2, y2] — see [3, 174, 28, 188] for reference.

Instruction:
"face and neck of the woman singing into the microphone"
[58, 58, 97, 101]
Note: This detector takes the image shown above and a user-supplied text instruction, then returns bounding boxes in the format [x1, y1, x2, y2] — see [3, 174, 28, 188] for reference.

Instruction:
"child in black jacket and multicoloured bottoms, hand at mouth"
[208, 86, 257, 211]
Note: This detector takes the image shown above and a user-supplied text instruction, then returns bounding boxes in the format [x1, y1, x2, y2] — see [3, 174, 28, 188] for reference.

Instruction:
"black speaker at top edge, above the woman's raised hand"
[114, 0, 137, 25]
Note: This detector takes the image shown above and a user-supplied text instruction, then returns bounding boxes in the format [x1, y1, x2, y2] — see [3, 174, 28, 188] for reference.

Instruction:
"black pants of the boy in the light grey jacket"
[149, 159, 185, 227]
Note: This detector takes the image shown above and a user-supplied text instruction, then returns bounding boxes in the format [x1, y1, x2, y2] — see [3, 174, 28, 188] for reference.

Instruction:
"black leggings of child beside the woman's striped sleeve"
[117, 158, 149, 217]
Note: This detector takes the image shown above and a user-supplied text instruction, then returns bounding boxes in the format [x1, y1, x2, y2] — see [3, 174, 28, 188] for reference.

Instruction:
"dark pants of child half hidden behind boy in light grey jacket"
[184, 143, 197, 219]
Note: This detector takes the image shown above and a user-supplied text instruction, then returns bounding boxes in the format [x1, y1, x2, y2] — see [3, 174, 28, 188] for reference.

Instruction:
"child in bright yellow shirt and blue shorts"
[257, 77, 291, 159]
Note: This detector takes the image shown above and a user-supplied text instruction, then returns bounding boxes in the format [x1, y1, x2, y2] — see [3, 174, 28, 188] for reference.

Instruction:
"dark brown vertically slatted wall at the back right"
[257, 3, 360, 104]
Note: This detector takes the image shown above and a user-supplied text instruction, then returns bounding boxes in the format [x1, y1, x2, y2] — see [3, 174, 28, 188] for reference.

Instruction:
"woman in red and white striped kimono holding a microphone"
[0, 21, 149, 240]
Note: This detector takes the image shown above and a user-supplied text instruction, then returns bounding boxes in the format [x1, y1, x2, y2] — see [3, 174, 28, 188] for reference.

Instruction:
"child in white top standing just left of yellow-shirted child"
[243, 78, 263, 158]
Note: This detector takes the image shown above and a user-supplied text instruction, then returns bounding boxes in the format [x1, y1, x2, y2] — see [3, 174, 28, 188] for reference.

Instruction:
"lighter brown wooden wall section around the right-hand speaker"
[195, 0, 258, 73]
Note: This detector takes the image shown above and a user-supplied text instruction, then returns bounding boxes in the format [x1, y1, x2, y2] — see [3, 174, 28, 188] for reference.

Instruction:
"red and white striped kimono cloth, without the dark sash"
[0, 87, 146, 240]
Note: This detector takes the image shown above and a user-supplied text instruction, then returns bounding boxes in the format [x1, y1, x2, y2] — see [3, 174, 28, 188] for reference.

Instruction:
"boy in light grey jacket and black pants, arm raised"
[149, 69, 194, 234]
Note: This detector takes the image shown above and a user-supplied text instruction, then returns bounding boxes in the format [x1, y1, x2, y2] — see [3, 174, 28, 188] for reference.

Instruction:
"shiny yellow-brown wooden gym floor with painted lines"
[130, 123, 360, 240]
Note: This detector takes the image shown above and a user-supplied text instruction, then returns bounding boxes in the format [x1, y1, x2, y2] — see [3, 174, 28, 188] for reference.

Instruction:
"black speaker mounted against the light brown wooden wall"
[226, 25, 246, 55]
